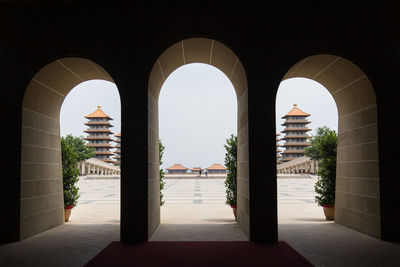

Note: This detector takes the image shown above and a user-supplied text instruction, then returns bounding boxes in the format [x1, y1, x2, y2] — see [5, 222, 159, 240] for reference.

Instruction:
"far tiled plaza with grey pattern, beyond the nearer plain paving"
[78, 177, 316, 207]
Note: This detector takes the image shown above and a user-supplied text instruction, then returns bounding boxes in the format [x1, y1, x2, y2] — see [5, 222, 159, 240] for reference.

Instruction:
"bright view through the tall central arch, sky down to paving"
[150, 63, 247, 241]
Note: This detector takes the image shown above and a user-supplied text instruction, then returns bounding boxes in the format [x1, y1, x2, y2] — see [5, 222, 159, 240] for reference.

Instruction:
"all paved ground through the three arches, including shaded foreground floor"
[0, 176, 400, 267]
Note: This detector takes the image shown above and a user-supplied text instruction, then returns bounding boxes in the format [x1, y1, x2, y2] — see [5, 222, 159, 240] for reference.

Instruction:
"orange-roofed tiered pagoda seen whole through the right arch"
[280, 104, 311, 162]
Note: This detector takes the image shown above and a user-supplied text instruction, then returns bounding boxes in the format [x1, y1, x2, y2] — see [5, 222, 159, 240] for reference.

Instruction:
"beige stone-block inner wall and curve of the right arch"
[283, 55, 381, 240]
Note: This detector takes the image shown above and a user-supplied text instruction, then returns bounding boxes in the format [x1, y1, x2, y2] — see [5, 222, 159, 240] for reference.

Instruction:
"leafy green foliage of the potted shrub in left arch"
[61, 137, 79, 207]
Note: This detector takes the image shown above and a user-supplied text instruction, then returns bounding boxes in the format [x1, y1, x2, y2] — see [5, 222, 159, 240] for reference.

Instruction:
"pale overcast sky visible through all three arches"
[60, 63, 337, 171]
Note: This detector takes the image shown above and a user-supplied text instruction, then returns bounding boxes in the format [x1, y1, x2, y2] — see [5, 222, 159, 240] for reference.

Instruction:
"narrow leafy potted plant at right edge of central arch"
[224, 134, 237, 220]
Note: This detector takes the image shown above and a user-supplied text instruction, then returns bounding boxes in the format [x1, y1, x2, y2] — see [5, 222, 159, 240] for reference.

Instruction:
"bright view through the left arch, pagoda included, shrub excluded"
[60, 80, 121, 228]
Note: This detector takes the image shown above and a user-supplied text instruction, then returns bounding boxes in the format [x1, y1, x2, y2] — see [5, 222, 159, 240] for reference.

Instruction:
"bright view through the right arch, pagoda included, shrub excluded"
[276, 78, 338, 239]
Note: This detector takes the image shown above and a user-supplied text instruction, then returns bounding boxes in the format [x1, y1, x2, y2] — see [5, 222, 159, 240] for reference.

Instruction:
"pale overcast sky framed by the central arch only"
[159, 64, 237, 171]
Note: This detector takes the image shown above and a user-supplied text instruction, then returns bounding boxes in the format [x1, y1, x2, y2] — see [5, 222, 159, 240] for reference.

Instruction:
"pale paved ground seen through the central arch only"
[150, 178, 247, 241]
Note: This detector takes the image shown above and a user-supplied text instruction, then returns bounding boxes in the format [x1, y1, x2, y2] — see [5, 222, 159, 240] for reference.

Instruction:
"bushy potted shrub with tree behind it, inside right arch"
[305, 126, 337, 220]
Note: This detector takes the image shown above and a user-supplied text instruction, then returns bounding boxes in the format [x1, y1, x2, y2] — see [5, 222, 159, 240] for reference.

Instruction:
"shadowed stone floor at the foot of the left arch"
[0, 223, 120, 266]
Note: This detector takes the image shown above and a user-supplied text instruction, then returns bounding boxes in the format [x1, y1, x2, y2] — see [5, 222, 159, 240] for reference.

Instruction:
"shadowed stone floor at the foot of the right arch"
[278, 221, 400, 266]
